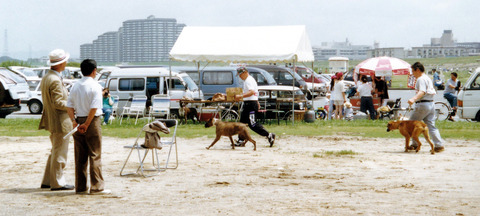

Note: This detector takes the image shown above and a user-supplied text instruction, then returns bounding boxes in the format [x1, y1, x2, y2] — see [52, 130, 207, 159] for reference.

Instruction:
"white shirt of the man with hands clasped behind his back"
[67, 77, 103, 117]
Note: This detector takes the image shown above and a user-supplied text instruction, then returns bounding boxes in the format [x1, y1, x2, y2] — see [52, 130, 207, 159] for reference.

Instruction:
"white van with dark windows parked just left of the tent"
[105, 66, 203, 118]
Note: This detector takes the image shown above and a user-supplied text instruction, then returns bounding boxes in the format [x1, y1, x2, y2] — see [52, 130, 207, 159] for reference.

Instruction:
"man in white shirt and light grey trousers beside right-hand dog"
[408, 62, 445, 152]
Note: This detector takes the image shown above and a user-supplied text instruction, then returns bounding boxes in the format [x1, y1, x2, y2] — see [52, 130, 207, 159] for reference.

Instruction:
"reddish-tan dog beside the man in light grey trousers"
[387, 120, 435, 154]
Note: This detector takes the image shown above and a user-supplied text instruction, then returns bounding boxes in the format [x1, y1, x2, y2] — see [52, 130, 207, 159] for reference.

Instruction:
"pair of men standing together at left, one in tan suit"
[39, 49, 111, 195]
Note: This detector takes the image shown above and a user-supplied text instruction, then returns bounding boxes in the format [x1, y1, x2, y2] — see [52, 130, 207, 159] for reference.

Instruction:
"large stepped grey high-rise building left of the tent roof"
[80, 16, 185, 63]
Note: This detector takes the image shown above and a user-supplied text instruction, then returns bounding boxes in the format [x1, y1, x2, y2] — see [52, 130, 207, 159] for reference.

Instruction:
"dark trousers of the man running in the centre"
[239, 101, 270, 139]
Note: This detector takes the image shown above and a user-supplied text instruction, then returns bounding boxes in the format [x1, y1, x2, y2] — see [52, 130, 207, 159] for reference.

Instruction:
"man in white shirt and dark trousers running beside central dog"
[235, 67, 275, 147]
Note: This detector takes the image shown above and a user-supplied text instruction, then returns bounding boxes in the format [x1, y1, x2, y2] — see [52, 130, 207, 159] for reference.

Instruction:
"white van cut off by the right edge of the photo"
[457, 67, 480, 122]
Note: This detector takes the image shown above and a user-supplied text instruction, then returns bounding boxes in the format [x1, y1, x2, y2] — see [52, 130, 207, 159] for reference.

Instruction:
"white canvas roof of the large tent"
[170, 26, 314, 63]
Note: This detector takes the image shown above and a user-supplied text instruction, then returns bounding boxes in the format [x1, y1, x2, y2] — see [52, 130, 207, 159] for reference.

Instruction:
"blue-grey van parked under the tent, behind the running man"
[175, 67, 277, 100]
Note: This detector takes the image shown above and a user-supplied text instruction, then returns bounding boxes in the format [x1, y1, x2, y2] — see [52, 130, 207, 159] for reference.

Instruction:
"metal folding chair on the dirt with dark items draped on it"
[120, 119, 178, 177]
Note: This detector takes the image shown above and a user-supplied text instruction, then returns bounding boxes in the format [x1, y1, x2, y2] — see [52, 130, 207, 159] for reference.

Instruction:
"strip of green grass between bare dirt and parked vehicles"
[0, 119, 480, 141]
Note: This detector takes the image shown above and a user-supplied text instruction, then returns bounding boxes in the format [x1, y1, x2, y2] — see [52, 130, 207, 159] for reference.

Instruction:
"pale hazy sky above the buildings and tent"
[0, 0, 480, 60]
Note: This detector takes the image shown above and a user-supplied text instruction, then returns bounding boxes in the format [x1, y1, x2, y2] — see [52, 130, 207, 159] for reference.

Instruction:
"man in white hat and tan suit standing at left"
[38, 49, 75, 191]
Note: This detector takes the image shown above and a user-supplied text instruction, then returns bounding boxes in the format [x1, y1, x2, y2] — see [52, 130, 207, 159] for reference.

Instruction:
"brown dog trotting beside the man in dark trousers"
[205, 118, 257, 151]
